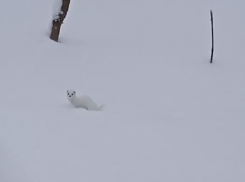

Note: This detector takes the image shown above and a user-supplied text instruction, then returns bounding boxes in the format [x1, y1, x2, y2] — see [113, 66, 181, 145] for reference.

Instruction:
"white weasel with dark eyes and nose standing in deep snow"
[67, 90, 103, 111]
